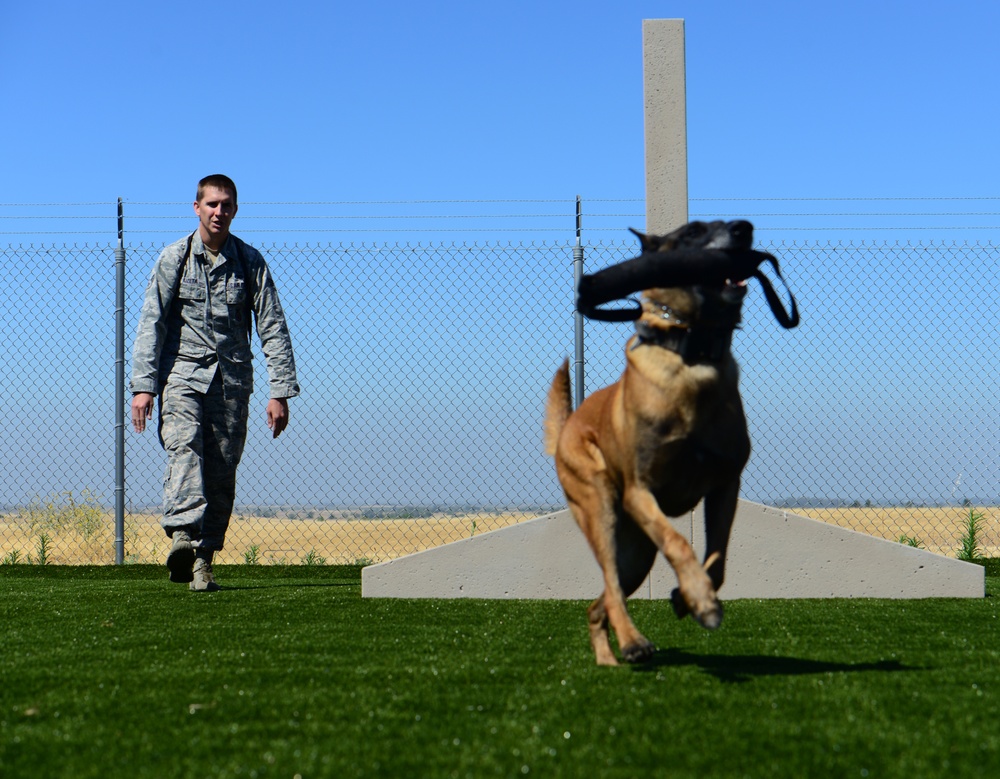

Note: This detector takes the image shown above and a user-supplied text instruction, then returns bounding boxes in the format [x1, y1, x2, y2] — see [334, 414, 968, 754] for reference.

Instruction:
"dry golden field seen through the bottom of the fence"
[0, 507, 1000, 565]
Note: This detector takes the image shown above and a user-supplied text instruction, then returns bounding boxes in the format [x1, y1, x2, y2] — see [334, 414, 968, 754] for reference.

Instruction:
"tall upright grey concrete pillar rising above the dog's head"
[642, 19, 688, 235]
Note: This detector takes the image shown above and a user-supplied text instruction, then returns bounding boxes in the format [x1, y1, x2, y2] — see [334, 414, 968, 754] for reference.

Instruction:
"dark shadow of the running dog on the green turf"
[633, 649, 920, 683]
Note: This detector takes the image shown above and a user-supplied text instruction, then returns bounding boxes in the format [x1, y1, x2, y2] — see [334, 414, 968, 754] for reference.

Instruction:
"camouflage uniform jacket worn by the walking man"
[131, 232, 299, 399]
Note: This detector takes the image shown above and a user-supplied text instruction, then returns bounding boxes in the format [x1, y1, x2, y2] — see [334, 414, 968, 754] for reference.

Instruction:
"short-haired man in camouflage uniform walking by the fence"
[131, 175, 299, 591]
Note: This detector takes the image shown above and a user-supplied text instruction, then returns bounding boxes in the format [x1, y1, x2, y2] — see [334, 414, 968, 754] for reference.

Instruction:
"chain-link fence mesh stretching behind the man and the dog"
[0, 235, 1000, 564]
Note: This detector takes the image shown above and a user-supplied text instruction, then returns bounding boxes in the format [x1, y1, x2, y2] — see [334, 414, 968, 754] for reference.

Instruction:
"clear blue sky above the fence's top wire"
[0, 0, 1000, 211]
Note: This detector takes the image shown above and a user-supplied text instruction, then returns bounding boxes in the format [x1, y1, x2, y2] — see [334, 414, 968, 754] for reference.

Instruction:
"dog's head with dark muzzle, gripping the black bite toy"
[632, 220, 753, 330]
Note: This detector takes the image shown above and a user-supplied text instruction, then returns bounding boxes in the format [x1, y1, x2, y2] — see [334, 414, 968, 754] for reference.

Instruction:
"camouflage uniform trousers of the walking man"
[159, 374, 249, 551]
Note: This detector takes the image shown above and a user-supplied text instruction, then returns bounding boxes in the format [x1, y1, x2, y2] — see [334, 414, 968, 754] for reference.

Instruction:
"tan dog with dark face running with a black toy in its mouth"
[545, 222, 753, 665]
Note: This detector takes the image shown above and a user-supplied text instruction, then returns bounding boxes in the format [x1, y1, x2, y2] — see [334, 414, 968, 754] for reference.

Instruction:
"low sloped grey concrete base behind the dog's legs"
[361, 501, 986, 600]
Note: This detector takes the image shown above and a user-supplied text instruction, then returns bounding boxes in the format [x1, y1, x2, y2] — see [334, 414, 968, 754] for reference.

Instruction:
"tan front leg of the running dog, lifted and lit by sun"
[612, 485, 722, 630]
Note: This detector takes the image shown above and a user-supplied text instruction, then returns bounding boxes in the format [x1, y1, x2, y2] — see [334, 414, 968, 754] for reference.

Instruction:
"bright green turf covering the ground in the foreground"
[0, 561, 1000, 779]
